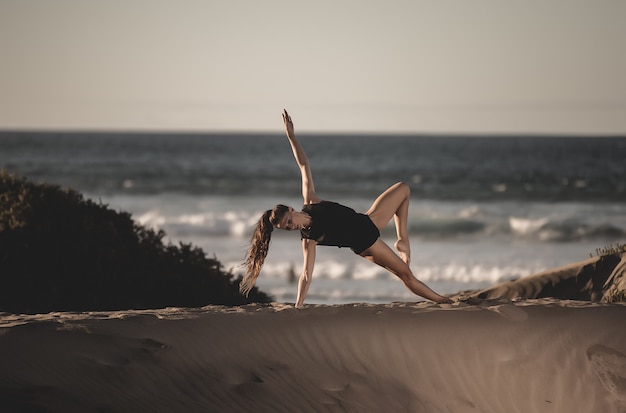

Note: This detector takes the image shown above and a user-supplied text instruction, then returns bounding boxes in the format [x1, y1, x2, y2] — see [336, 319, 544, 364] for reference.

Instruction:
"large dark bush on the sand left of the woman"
[0, 171, 271, 313]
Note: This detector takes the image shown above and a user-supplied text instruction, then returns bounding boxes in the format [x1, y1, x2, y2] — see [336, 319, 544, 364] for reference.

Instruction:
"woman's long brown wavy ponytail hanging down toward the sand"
[239, 205, 289, 297]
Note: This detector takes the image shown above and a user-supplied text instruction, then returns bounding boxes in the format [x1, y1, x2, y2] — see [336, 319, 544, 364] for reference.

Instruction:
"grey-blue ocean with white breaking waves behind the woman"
[0, 131, 626, 304]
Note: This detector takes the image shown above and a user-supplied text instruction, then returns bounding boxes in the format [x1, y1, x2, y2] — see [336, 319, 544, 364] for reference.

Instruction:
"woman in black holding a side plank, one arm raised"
[239, 110, 452, 307]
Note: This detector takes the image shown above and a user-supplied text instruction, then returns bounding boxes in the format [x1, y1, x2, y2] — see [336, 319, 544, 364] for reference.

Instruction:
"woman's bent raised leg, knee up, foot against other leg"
[366, 182, 411, 265]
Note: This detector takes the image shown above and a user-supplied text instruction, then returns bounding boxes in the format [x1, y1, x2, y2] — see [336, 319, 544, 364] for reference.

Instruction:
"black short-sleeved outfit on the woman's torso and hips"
[300, 201, 380, 254]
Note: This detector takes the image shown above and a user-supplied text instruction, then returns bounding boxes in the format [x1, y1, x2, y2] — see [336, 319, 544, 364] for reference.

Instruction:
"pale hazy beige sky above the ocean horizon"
[0, 0, 626, 135]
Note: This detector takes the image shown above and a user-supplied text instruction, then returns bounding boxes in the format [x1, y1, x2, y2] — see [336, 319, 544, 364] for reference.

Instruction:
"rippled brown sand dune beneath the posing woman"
[0, 253, 626, 413]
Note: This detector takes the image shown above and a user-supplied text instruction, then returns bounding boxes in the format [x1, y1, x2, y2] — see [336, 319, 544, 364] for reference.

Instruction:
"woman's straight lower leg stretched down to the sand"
[361, 238, 452, 304]
